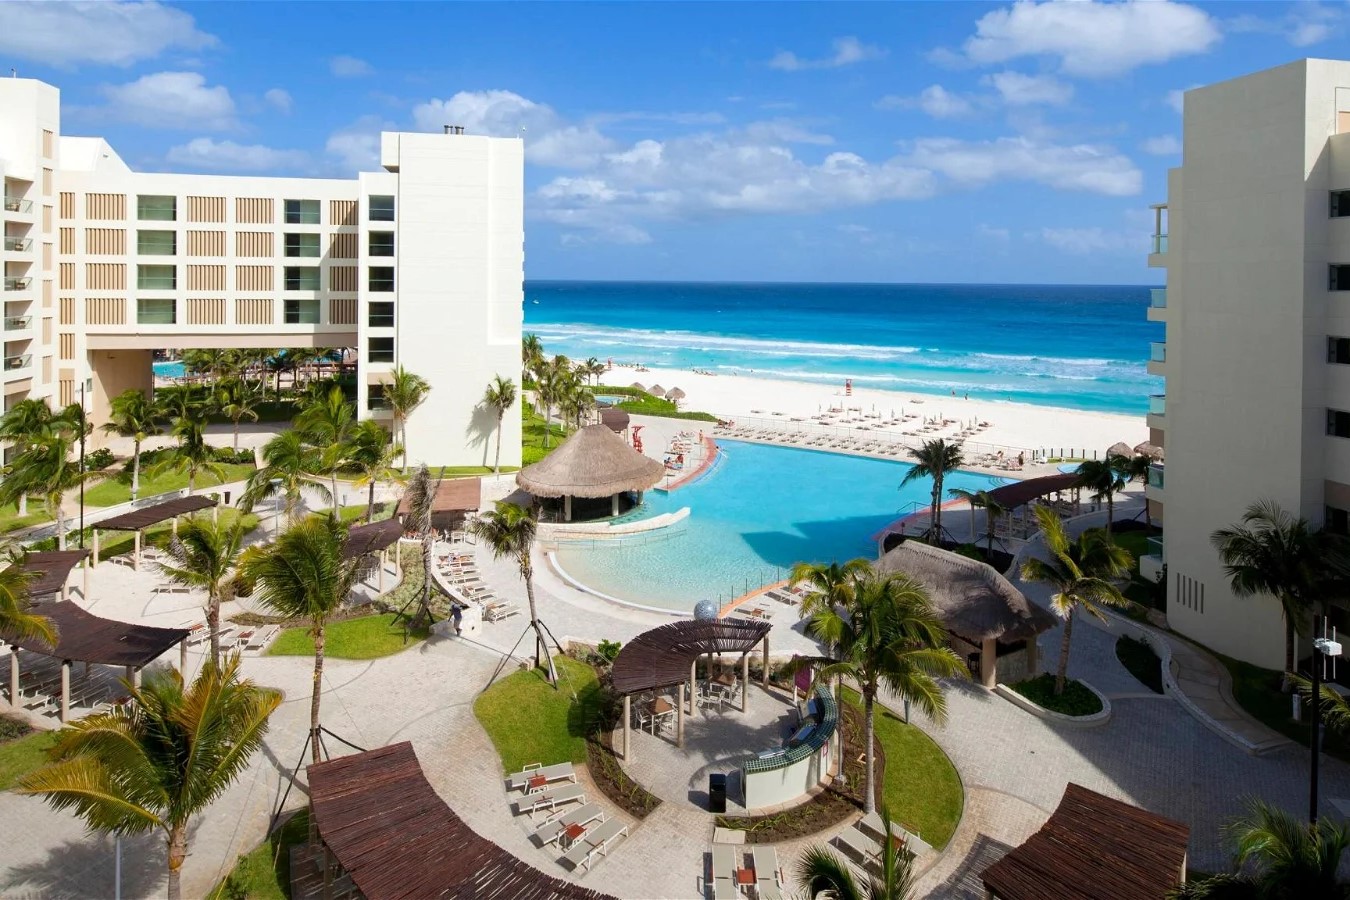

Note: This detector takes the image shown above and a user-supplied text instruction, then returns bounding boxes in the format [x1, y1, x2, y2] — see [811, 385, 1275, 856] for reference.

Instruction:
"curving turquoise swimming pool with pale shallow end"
[558, 441, 1004, 611]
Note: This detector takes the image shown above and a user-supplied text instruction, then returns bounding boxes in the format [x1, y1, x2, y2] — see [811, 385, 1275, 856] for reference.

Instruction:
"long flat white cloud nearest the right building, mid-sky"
[905, 138, 1143, 197]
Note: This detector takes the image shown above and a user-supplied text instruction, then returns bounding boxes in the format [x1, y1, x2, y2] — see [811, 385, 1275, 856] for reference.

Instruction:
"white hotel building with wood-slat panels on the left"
[0, 78, 524, 466]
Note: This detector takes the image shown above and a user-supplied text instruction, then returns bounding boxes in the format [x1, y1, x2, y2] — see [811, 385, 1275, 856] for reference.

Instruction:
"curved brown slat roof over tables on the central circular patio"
[610, 619, 774, 694]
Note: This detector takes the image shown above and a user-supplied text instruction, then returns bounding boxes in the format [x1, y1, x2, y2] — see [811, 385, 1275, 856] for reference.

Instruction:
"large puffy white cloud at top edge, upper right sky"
[964, 0, 1220, 78]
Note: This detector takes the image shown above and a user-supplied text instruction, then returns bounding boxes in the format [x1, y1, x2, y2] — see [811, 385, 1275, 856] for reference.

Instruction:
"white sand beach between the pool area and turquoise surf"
[598, 366, 1149, 453]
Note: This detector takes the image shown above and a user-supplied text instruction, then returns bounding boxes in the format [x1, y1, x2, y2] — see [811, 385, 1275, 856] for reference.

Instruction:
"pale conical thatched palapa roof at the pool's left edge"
[516, 425, 666, 498]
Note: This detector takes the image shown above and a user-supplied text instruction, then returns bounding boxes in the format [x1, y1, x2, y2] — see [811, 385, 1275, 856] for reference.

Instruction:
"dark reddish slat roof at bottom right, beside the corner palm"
[980, 784, 1191, 900]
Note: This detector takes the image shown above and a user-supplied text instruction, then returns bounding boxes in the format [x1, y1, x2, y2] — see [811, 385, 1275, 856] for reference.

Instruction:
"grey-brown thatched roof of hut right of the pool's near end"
[876, 540, 1058, 644]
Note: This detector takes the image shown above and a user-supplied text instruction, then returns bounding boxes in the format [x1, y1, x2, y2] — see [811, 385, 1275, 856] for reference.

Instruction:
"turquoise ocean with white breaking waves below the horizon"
[525, 281, 1162, 416]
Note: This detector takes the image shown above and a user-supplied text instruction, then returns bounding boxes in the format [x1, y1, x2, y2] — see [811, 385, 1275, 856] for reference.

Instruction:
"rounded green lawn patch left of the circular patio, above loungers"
[474, 656, 601, 772]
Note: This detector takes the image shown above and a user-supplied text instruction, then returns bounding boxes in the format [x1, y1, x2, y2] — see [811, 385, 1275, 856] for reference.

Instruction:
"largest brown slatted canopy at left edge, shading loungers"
[4, 600, 188, 668]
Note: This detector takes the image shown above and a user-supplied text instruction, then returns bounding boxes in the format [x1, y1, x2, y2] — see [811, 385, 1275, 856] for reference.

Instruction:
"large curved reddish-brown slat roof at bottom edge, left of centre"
[306, 741, 608, 900]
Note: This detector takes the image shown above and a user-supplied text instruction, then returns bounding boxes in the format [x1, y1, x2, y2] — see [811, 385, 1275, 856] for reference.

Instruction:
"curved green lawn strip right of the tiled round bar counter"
[844, 688, 965, 849]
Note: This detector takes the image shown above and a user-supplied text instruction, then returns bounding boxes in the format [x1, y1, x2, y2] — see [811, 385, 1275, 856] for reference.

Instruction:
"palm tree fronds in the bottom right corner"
[1168, 800, 1350, 900]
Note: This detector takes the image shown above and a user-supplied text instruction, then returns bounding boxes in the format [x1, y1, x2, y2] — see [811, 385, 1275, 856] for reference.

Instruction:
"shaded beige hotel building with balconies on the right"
[1141, 59, 1350, 668]
